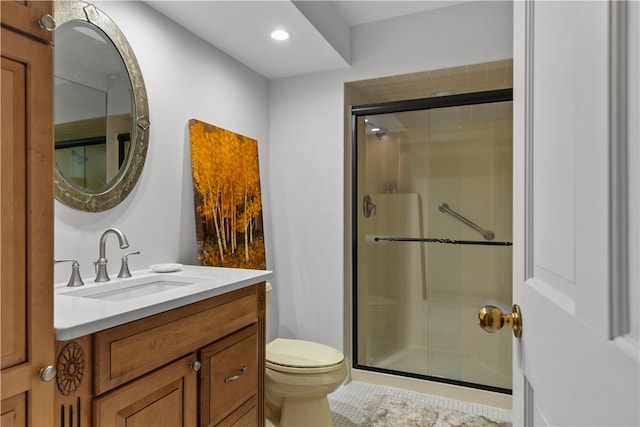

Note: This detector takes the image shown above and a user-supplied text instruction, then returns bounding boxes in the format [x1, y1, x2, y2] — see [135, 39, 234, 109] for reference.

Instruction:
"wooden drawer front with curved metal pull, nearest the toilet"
[199, 324, 258, 426]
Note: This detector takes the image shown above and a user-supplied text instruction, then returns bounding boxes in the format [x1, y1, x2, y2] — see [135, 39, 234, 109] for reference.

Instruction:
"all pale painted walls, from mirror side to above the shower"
[55, 1, 512, 349]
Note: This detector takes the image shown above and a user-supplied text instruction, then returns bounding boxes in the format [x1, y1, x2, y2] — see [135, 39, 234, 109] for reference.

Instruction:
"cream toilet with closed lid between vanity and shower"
[265, 283, 348, 427]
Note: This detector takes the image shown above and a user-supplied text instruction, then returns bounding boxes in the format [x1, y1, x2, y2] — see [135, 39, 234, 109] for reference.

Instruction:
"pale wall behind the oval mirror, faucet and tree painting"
[55, 1, 274, 288]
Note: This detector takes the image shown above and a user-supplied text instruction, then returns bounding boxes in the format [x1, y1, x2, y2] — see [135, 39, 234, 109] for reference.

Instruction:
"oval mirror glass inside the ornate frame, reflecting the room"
[54, 21, 132, 194]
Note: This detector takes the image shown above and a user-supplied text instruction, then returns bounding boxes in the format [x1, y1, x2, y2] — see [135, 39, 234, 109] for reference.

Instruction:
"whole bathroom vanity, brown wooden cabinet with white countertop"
[54, 266, 271, 427]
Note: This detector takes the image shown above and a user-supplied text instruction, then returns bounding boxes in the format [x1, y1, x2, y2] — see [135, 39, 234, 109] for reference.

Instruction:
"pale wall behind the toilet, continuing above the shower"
[269, 1, 513, 349]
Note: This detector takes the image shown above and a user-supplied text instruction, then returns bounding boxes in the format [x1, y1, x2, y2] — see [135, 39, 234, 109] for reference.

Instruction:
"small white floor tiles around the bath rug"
[329, 381, 511, 427]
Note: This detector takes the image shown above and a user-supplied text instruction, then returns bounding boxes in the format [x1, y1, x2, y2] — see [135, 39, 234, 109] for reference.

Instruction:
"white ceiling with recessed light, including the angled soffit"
[145, 0, 469, 79]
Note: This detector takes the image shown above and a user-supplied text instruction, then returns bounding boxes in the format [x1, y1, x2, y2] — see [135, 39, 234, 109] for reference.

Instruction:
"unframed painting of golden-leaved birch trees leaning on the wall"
[189, 119, 266, 269]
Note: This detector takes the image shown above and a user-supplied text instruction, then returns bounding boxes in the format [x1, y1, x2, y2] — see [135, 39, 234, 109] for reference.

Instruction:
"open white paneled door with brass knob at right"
[510, 1, 640, 426]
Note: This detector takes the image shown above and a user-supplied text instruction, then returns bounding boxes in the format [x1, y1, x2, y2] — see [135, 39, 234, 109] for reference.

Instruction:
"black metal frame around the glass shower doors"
[350, 89, 513, 394]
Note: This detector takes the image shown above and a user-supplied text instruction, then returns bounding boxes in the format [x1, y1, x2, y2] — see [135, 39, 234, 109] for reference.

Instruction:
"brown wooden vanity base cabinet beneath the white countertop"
[56, 283, 265, 427]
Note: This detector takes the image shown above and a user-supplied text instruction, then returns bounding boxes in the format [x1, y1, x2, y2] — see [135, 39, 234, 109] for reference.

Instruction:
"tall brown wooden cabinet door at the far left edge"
[0, 21, 55, 427]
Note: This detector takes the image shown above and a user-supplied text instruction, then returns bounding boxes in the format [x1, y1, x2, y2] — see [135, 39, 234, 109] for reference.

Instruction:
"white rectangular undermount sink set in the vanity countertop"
[60, 274, 207, 301]
